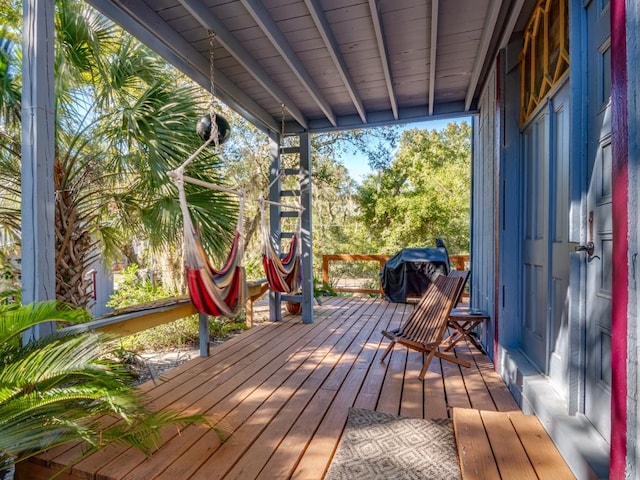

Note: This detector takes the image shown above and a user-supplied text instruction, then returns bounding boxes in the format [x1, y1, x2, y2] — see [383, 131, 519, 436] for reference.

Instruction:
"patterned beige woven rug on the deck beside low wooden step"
[325, 408, 460, 480]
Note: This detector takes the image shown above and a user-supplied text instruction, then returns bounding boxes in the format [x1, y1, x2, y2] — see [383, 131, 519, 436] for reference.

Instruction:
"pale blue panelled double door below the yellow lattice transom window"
[521, 79, 571, 386]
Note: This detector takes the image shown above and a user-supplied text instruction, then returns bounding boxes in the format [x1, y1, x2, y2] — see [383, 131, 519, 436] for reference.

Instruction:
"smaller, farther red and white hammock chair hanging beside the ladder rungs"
[260, 200, 302, 293]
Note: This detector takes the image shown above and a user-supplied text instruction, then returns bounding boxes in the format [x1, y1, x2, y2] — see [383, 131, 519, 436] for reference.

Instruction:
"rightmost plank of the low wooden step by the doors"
[509, 413, 575, 480]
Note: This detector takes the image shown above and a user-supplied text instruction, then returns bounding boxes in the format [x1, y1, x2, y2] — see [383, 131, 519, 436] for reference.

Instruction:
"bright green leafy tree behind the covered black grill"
[357, 122, 471, 253]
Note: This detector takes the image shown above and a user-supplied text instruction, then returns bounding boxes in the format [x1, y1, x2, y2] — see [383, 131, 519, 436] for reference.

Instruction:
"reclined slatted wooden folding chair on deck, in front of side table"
[381, 270, 471, 380]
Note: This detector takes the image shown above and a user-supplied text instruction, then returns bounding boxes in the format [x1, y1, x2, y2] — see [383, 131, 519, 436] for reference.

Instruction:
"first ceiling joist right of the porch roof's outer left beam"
[180, 0, 308, 129]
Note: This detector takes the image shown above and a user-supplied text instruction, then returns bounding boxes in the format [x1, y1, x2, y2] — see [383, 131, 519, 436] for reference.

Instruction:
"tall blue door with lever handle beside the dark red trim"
[585, 1, 613, 441]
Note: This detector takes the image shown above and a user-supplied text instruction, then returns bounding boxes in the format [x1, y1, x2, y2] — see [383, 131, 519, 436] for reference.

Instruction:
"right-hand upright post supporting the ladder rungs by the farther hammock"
[299, 132, 313, 323]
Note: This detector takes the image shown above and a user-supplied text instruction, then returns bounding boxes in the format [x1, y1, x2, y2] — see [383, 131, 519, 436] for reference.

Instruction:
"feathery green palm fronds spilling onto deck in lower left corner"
[0, 302, 203, 469]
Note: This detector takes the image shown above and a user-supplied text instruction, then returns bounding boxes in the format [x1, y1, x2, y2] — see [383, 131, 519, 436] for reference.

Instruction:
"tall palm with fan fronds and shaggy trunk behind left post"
[0, 0, 237, 306]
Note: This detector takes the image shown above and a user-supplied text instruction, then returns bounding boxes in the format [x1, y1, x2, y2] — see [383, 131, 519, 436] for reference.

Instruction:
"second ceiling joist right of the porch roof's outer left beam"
[240, 0, 337, 126]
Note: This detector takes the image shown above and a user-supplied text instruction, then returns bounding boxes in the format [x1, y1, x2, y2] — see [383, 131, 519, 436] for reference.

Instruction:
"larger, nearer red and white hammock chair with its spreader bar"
[168, 142, 247, 318]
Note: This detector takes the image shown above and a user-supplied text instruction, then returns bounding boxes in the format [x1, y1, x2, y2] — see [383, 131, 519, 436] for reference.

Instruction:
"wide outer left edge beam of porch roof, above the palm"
[87, 0, 280, 131]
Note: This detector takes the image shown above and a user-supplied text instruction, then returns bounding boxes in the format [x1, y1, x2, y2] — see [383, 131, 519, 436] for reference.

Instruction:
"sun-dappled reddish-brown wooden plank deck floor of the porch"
[17, 297, 519, 480]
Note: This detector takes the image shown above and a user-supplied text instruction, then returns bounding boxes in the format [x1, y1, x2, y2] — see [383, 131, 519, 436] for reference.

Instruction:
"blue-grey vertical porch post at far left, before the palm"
[21, 0, 56, 341]
